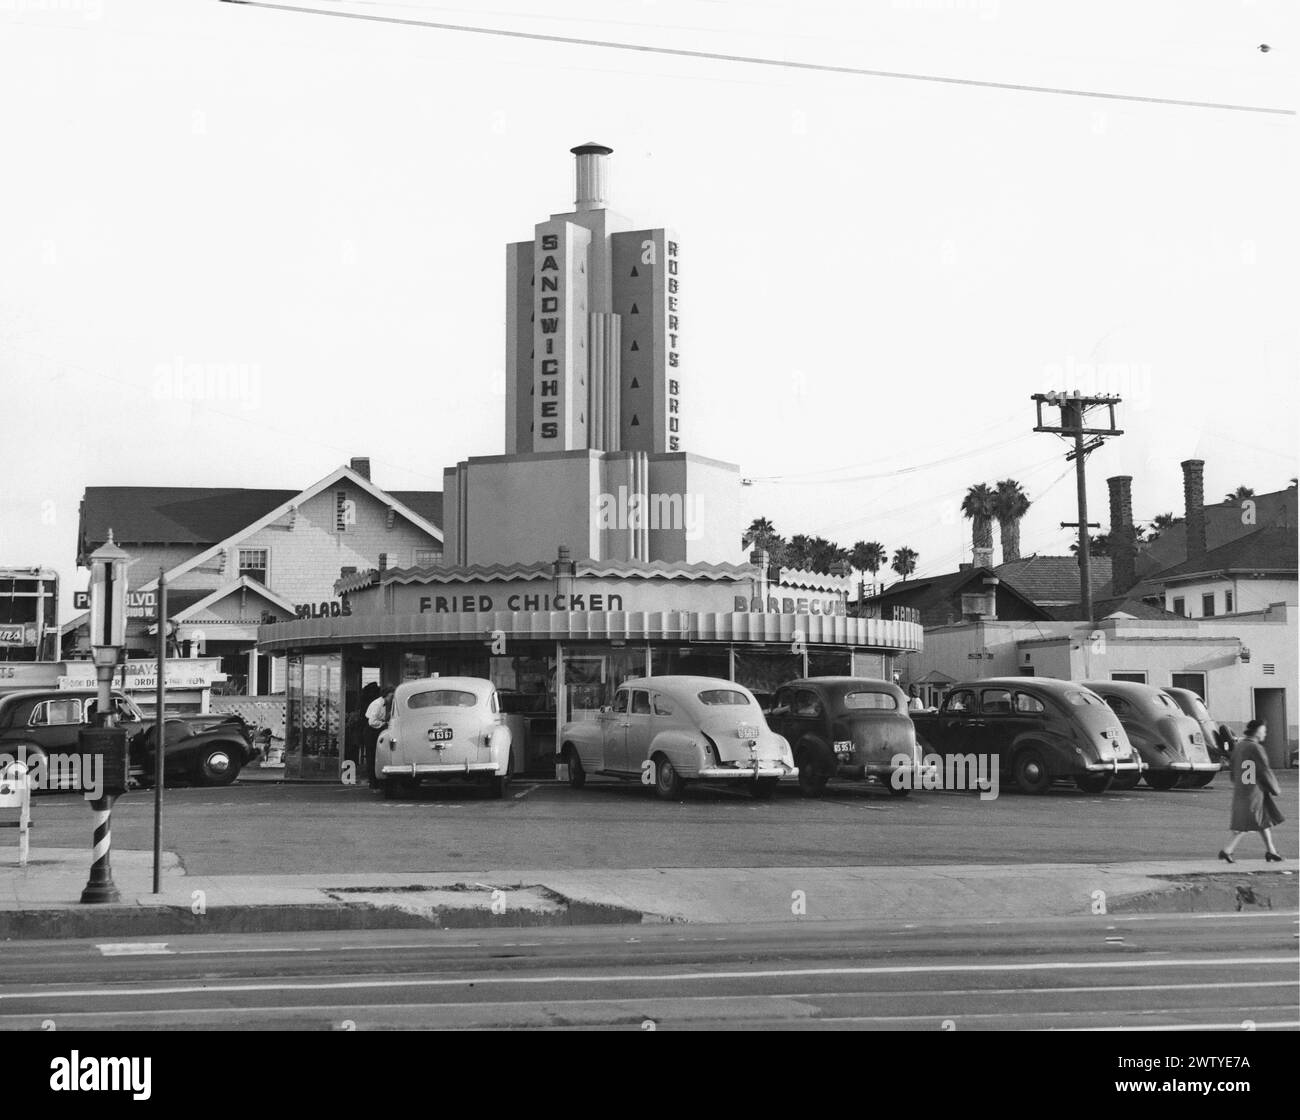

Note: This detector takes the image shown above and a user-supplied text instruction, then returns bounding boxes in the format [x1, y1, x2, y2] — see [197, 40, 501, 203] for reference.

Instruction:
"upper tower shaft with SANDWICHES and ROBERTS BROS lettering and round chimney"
[506, 144, 683, 455]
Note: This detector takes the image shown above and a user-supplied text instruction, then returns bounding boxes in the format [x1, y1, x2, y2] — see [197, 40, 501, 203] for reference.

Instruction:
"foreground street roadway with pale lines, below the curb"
[0, 913, 1300, 1029]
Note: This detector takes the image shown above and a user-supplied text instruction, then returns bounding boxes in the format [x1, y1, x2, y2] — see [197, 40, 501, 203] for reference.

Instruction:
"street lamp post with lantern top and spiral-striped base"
[81, 529, 129, 902]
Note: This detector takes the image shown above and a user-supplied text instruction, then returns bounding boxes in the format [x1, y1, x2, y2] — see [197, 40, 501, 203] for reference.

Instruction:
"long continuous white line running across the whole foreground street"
[0, 956, 1296, 1000]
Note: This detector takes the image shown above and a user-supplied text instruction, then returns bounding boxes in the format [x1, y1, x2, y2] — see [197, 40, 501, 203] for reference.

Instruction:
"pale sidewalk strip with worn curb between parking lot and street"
[0, 848, 1297, 938]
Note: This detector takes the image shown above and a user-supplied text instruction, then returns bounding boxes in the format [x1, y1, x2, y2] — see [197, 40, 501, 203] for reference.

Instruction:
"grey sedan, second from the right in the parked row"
[1083, 681, 1219, 790]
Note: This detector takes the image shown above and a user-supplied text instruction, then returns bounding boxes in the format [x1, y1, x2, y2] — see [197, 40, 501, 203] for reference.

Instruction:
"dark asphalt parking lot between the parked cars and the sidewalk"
[12, 770, 1300, 876]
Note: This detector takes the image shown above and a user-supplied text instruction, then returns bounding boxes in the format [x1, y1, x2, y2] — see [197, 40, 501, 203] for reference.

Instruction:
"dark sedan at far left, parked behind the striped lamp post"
[0, 689, 257, 786]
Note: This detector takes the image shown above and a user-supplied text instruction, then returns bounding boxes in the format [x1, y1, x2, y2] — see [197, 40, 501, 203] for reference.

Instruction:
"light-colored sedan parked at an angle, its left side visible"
[560, 677, 796, 799]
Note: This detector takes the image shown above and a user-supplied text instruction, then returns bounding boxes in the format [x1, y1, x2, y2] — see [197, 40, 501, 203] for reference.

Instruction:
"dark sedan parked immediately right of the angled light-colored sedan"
[767, 677, 920, 798]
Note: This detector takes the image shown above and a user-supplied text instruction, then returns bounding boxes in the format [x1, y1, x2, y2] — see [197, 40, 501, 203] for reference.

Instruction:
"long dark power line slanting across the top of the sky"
[221, 0, 1296, 117]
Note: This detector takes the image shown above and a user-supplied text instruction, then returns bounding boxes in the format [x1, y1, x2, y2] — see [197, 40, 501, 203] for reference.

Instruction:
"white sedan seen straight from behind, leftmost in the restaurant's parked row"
[374, 677, 514, 798]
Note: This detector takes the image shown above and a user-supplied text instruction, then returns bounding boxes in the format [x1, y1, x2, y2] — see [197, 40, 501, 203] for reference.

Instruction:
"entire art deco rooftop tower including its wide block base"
[442, 144, 741, 569]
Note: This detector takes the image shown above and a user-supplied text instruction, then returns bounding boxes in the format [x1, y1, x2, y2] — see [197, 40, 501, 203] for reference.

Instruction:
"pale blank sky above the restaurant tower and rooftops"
[0, 0, 1297, 613]
